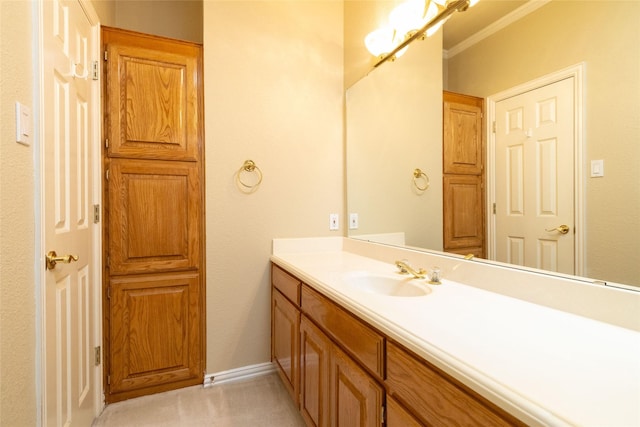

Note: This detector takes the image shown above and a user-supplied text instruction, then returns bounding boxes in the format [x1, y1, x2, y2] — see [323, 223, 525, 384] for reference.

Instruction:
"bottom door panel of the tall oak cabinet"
[109, 274, 202, 393]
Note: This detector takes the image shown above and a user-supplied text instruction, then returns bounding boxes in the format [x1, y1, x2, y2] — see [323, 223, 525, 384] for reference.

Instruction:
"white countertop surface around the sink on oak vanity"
[272, 250, 640, 427]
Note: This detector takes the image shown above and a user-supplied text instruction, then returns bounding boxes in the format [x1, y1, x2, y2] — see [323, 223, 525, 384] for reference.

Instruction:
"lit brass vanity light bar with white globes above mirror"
[365, 0, 478, 68]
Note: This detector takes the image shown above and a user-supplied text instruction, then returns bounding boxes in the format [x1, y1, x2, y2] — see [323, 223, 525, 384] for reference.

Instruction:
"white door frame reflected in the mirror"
[486, 62, 586, 276]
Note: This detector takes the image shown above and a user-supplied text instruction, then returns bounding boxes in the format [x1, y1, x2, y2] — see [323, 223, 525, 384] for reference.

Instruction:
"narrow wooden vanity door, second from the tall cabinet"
[300, 316, 332, 427]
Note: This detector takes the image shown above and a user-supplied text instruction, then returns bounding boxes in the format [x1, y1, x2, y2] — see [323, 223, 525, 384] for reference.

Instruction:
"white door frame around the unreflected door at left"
[33, 0, 104, 425]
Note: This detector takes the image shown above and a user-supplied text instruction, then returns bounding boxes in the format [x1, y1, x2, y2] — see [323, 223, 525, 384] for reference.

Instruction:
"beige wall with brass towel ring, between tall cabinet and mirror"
[204, 1, 344, 373]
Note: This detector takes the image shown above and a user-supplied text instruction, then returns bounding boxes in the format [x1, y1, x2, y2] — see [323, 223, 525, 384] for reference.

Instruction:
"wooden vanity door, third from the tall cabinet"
[330, 346, 384, 427]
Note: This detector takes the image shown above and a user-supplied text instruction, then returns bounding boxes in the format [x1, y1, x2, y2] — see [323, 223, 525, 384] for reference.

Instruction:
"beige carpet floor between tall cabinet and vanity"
[93, 373, 304, 427]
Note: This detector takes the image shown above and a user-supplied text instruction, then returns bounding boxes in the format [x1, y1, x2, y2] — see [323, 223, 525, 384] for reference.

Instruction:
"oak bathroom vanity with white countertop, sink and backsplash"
[271, 238, 640, 427]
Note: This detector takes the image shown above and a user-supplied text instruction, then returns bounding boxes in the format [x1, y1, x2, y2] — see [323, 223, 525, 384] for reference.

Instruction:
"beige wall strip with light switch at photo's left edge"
[0, 0, 38, 426]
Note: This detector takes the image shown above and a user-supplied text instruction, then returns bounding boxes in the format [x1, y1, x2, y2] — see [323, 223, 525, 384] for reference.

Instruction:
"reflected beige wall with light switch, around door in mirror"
[448, 1, 640, 285]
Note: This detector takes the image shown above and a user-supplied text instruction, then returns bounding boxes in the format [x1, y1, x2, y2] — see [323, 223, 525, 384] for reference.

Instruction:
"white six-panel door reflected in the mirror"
[495, 78, 576, 274]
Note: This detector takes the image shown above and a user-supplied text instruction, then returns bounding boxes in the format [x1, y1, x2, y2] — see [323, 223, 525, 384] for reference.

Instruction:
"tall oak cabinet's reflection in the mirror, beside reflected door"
[442, 91, 486, 258]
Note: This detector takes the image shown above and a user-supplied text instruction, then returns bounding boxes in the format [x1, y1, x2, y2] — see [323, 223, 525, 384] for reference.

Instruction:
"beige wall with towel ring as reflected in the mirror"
[346, 32, 443, 250]
